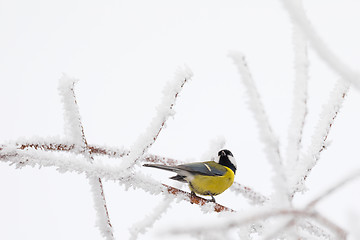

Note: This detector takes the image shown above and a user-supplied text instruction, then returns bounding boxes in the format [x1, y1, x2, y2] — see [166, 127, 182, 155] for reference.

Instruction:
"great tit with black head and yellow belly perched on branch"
[143, 149, 236, 202]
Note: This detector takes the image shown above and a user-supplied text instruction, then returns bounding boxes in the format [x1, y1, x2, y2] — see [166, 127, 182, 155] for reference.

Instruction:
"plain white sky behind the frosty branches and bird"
[0, 0, 360, 239]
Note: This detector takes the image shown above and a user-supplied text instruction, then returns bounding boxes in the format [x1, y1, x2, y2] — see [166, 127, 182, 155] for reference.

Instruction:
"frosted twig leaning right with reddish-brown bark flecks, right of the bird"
[289, 80, 349, 194]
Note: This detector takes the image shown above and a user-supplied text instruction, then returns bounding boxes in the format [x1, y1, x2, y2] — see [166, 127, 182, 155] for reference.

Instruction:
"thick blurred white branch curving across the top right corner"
[280, 0, 360, 89]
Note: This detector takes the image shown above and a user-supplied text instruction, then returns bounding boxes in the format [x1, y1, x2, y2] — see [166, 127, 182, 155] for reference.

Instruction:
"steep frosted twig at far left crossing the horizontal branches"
[59, 75, 114, 240]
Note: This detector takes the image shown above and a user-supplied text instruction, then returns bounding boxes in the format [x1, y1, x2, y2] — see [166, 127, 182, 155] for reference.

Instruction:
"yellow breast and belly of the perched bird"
[189, 167, 235, 196]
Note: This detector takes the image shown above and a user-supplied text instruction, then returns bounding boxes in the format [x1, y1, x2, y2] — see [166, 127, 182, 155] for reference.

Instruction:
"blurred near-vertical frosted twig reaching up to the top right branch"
[286, 0, 309, 168]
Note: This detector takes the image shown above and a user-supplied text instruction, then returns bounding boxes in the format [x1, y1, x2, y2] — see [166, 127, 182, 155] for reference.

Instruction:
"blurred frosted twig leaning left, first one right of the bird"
[230, 52, 288, 205]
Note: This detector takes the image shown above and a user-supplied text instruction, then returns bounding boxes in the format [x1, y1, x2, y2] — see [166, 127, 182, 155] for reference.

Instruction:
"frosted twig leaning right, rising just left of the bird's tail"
[122, 67, 193, 169]
